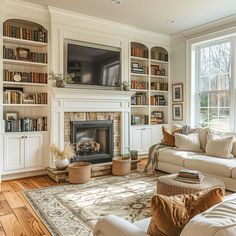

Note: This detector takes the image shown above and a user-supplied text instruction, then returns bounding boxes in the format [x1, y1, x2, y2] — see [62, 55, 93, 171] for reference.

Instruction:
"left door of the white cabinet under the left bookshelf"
[3, 135, 24, 171]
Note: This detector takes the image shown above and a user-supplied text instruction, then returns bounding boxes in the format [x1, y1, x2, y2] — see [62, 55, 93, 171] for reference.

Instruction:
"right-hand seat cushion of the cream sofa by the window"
[184, 155, 236, 178]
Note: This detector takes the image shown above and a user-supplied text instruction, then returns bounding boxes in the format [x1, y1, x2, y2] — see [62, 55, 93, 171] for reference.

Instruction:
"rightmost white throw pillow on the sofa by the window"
[206, 133, 234, 158]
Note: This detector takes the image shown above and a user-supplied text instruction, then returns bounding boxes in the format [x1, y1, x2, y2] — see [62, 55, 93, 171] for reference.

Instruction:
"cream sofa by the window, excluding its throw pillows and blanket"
[156, 128, 236, 191]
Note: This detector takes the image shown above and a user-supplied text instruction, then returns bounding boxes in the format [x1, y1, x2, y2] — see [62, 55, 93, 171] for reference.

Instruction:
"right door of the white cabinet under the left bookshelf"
[25, 134, 43, 168]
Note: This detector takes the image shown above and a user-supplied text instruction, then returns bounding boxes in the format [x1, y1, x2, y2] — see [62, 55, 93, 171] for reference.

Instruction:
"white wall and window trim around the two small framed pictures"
[170, 16, 236, 124]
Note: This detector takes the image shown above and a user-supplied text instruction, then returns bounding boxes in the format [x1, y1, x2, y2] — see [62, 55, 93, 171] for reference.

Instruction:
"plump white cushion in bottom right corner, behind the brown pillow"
[180, 194, 236, 236]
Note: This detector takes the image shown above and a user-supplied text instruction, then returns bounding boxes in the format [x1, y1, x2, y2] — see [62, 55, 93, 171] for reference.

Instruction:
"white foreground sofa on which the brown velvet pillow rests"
[93, 194, 236, 236]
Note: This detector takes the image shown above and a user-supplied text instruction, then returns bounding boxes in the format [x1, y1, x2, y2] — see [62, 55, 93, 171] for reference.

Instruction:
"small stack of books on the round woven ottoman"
[176, 169, 204, 184]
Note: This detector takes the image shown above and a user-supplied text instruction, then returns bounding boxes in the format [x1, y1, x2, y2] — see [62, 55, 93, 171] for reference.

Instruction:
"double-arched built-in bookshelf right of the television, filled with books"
[130, 42, 169, 125]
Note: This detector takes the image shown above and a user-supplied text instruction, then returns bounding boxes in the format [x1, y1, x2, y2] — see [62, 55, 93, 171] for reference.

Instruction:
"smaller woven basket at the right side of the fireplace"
[112, 157, 131, 175]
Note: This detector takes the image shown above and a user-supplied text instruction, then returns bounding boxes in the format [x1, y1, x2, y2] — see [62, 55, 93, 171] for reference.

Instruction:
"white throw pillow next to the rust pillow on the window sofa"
[175, 133, 202, 152]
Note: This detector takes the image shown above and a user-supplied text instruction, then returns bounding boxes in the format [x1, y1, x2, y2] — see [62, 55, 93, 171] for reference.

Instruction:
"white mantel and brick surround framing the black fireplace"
[50, 88, 133, 167]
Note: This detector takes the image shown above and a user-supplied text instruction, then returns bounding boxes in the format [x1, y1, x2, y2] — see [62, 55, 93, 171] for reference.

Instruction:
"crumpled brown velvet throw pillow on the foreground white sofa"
[148, 188, 224, 236]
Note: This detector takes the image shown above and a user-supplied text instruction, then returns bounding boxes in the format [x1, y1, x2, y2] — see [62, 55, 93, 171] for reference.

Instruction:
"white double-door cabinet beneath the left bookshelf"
[3, 133, 44, 173]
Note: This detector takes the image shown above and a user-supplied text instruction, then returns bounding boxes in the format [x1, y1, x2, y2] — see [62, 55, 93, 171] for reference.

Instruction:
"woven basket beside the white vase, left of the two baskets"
[68, 161, 91, 184]
